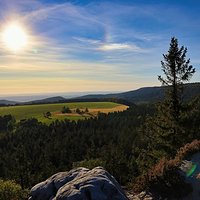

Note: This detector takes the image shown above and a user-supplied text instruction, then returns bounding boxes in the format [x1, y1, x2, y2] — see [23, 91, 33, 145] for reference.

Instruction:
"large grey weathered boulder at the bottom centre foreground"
[29, 167, 128, 200]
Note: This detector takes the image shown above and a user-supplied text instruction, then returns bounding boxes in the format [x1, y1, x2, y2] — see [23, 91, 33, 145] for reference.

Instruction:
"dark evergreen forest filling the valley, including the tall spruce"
[0, 38, 200, 199]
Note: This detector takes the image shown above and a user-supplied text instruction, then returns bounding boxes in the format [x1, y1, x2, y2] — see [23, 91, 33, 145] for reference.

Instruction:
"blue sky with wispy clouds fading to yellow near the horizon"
[0, 0, 200, 95]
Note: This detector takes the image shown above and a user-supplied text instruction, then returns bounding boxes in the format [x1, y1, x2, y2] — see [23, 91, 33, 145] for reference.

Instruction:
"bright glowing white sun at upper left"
[2, 22, 28, 52]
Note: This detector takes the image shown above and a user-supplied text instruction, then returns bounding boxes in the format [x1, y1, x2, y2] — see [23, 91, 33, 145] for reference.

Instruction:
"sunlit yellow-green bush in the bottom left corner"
[0, 179, 28, 200]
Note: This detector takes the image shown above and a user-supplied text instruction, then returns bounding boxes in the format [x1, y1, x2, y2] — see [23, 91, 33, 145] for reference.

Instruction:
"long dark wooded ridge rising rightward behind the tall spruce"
[76, 83, 200, 104]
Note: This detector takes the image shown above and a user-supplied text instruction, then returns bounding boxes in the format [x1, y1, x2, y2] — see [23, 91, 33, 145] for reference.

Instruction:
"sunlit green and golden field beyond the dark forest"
[0, 102, 127, 123]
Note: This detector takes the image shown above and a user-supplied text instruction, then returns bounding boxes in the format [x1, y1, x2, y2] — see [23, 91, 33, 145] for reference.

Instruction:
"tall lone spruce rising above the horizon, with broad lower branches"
[144, 37, 195, 157]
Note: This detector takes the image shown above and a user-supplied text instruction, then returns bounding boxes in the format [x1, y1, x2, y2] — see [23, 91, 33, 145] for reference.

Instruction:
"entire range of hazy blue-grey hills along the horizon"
[0, 83, 200, 105]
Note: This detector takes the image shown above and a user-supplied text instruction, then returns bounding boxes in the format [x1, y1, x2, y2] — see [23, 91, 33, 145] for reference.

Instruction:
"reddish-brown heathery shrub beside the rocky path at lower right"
[133, 140, 200, 198]
